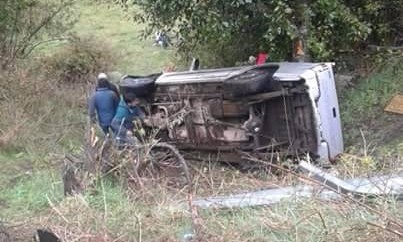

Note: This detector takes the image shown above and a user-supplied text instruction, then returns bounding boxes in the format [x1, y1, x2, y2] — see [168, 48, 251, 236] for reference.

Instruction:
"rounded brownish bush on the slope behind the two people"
[43, 37, 117, 83]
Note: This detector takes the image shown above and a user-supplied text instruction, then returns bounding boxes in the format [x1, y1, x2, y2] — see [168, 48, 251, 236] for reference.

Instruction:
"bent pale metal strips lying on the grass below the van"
[193, 161, 403, 208]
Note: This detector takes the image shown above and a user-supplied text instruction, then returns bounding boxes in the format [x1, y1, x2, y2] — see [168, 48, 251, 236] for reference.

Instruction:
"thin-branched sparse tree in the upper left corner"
[0, 0, 75, 68]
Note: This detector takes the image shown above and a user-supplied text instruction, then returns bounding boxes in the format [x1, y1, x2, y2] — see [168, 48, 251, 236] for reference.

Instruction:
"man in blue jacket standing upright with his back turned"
[88, 76, 119, 135]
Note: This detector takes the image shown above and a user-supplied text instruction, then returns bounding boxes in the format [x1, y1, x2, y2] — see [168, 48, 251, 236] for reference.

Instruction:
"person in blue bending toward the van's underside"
[112, 93, 145, 143]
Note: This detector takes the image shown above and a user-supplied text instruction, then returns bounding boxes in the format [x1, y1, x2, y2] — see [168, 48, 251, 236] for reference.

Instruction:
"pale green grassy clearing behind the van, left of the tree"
[73, 1, 173, 75]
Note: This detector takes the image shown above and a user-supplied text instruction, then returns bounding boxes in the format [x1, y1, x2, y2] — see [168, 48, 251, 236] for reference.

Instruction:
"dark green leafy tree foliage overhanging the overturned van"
[116, 0, 402, 65]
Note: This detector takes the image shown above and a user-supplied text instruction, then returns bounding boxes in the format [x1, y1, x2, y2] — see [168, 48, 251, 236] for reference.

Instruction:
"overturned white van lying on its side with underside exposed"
[121, 63, 343, 162]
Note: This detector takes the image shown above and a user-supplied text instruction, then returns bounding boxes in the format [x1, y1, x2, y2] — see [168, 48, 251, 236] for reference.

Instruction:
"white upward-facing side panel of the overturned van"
[156, 62, 329, 85]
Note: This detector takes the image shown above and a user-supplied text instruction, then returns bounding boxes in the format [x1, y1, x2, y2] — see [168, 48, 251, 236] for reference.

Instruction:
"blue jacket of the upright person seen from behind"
[88, 88, 119, 127]
